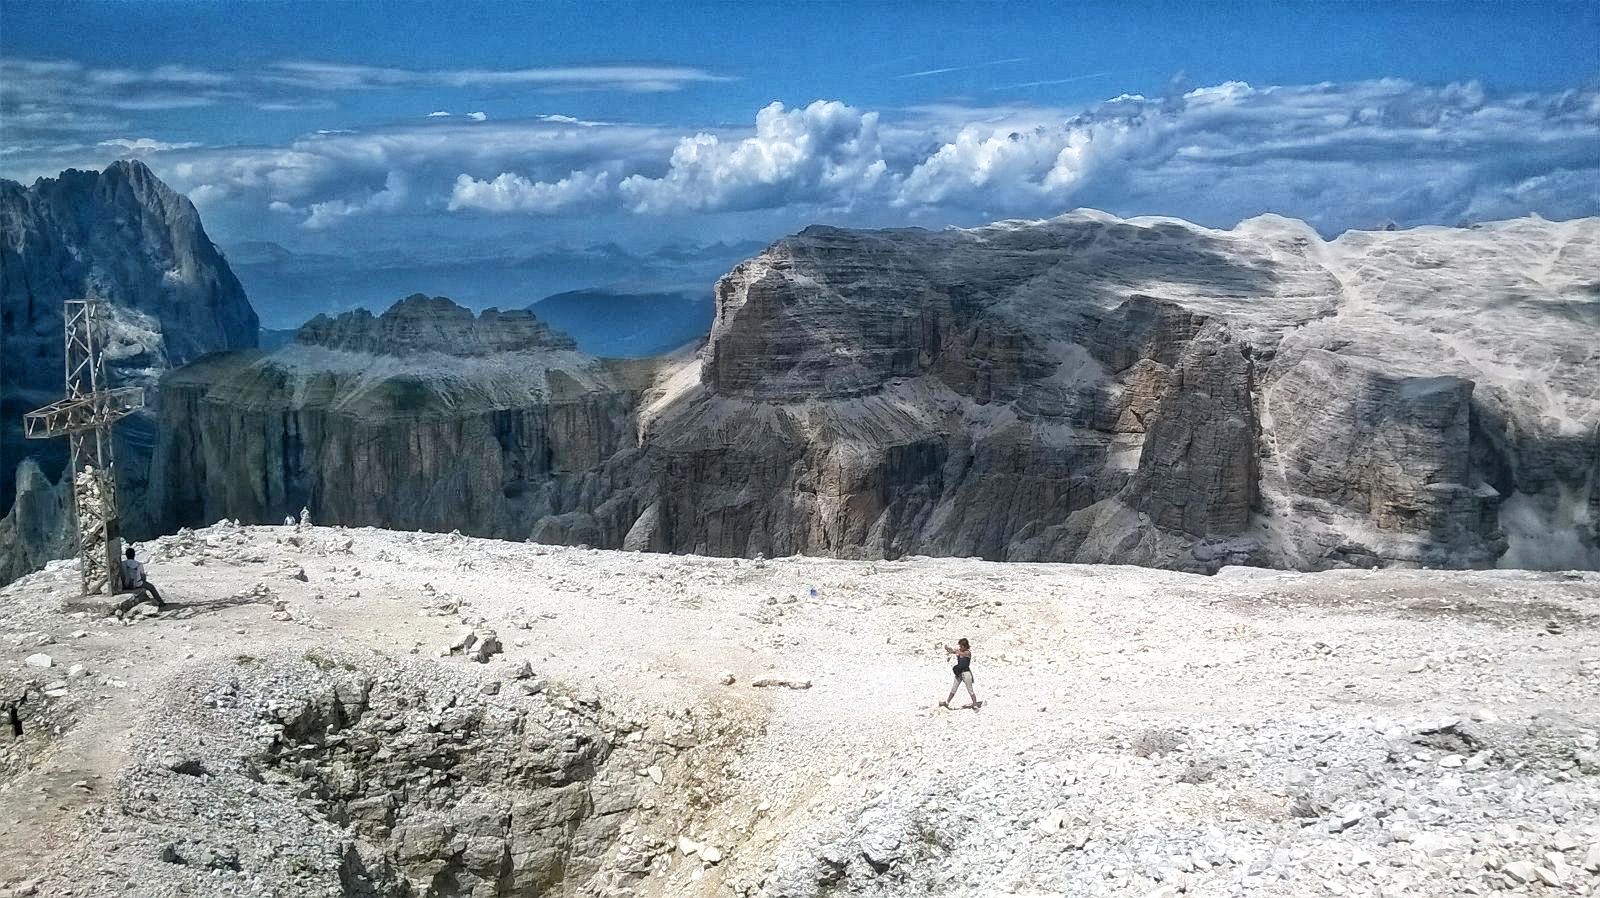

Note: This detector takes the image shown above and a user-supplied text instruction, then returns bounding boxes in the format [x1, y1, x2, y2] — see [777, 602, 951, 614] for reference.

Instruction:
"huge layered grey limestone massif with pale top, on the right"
[592, 213, 1600, 570]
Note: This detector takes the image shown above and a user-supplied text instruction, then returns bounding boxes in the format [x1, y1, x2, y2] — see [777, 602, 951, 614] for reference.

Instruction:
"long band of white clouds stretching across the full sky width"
[21, 77, 1600, 237]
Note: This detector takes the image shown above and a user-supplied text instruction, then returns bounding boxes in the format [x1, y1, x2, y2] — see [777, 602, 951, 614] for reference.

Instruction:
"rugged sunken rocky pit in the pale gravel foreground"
[109, 651, 675, 898]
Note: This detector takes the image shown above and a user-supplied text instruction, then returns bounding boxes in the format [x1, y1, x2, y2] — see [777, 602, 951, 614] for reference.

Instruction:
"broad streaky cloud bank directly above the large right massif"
[893, 80, 1600, 231]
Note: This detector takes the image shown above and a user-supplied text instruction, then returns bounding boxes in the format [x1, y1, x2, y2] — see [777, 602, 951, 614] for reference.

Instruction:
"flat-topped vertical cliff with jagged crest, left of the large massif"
[152, 295, 637, 539]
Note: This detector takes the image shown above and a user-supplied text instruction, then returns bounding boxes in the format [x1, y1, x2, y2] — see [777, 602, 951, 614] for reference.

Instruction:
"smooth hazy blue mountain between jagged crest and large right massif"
[528, 288, 715, 357]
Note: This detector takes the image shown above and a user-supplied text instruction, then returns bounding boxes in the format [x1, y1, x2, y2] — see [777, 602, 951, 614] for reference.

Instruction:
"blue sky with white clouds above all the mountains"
[0, 0, 1600, 319]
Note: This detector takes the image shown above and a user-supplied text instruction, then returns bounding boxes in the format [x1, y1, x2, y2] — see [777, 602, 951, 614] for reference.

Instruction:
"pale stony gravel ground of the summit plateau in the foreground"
[0, 523, 1600, 898]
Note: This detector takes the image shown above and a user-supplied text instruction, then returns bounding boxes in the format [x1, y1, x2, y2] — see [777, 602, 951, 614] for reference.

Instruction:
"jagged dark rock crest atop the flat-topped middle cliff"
[294, 293, 578, 355]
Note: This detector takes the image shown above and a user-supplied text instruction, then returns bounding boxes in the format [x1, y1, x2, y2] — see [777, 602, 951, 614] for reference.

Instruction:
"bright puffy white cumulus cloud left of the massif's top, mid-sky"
[618, 99, 886, 213]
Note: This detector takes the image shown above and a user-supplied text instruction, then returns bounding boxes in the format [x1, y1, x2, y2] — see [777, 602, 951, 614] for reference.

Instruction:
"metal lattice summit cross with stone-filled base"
[22, 299, 144, 595]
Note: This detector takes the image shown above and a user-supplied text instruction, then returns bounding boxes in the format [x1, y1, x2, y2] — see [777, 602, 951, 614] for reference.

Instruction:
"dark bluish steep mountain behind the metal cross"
[0, 162, 258, 569]
